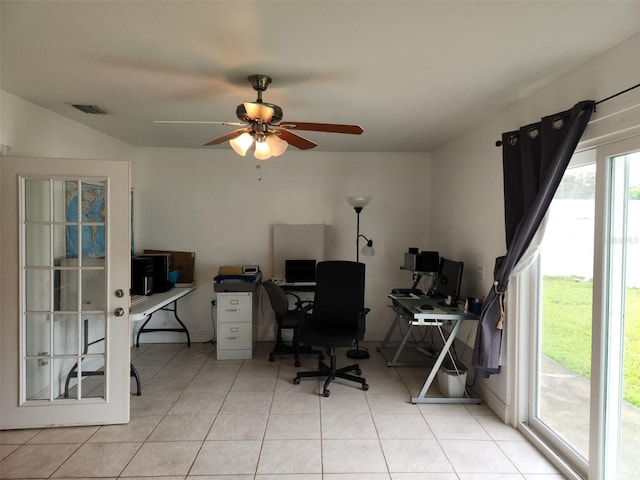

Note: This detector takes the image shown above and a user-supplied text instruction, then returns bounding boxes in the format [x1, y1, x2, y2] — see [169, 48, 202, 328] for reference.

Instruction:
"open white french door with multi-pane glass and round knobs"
[0, 157, 130, 429]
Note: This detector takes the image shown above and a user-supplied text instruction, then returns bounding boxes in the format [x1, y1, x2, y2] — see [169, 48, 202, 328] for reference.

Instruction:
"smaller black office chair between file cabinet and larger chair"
[262, 280, 323, 367]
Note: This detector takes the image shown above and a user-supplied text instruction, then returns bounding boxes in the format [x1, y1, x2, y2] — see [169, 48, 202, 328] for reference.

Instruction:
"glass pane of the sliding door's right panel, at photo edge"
[604, 153, 640, 479]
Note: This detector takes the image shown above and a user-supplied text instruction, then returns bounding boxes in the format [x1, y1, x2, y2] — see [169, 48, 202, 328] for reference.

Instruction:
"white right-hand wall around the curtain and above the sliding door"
[431, 31, 640, 418]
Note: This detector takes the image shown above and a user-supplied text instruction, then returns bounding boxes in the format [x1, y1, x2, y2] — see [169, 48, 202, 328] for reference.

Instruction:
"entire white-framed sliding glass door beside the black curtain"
[518, 137, 640, 480]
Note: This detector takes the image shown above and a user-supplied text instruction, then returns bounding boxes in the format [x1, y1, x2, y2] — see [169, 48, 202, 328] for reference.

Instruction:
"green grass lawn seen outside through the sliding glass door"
[542, 276, 640, 407]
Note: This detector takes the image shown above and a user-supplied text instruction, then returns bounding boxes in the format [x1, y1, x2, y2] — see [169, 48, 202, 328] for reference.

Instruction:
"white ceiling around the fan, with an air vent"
[0, 0, 640, 152]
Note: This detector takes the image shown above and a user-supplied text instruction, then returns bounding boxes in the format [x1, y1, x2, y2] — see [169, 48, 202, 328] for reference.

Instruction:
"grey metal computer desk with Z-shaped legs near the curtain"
[377, 294, 482, 403]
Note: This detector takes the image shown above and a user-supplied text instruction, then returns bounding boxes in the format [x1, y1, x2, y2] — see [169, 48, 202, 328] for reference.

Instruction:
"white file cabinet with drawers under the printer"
[217, 292, 258, 360]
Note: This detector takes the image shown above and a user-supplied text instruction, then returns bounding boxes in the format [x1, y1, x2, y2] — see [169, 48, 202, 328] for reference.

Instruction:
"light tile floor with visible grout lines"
[0, 343, 563, 480]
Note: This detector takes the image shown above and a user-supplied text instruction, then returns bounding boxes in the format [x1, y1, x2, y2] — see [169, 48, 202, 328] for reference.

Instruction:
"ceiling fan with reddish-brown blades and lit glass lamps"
[159, 75, 364, 160]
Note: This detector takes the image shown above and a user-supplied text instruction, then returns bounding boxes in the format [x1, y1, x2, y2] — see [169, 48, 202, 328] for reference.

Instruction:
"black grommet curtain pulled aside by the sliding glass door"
[472, 100, 595, 377]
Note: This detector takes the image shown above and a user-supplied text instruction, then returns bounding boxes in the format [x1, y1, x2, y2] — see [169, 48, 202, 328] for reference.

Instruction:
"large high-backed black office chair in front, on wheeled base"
[293, 260, 369, 397]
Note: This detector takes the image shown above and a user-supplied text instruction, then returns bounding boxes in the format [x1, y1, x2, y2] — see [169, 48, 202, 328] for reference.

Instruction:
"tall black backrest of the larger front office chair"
[313, 260, 365, 325]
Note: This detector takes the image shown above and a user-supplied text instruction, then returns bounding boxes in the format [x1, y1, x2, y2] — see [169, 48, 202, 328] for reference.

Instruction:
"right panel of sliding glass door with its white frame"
[590, 141, 640, 480]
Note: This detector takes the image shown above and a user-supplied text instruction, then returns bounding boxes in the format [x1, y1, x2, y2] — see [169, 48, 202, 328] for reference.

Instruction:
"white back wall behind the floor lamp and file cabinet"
[132, 148, 431, 341]
